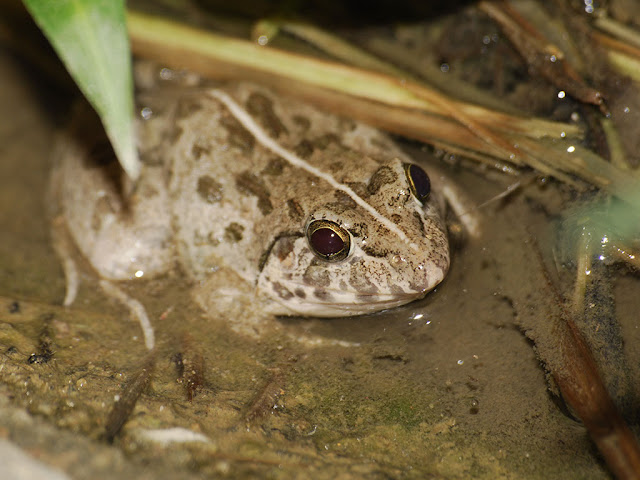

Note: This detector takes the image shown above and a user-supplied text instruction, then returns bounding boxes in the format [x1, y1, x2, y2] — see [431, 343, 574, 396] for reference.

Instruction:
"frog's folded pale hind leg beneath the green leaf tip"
[50, 104, 174, 280]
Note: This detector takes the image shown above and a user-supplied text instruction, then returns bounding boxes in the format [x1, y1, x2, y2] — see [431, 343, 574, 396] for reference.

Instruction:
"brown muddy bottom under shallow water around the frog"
[0, 46, 640, 479]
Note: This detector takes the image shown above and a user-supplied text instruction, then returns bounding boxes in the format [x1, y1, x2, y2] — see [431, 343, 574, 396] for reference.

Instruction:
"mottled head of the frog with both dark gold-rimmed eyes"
[257, 158, 449, 317]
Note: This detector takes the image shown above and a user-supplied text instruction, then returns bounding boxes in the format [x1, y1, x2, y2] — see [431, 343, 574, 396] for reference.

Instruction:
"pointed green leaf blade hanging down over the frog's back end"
[23, 0, 140, 179]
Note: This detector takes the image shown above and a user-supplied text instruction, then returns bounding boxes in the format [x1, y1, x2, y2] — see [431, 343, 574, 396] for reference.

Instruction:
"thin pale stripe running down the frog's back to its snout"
[209, 90, 417, 249]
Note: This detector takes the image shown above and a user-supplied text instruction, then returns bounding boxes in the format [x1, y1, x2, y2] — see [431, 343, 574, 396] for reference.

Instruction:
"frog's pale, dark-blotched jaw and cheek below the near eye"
[256, 225, 449, 318]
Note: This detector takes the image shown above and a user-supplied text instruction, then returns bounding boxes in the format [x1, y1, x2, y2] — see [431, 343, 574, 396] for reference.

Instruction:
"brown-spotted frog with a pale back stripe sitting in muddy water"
[52, 76, 450, 338]
